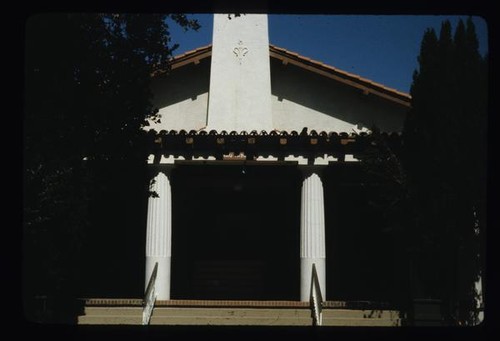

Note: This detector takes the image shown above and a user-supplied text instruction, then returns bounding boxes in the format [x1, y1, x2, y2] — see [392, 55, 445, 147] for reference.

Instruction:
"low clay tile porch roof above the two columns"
[147, 129, 402, 162]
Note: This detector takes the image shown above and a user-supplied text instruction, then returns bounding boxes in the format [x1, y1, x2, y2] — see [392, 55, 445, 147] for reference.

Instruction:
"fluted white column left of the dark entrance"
[144, 171, 172, 300]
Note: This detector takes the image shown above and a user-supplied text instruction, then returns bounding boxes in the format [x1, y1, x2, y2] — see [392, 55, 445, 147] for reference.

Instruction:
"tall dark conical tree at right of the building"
[402, 18, 487, 324]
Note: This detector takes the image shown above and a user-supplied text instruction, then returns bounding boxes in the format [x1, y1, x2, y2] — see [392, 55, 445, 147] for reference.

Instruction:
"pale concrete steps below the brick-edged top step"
[78, 306, 401, 326]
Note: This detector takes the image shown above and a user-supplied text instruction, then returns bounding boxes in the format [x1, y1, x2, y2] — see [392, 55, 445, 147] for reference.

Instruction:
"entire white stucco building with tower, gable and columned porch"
[82, 14, 410, 325]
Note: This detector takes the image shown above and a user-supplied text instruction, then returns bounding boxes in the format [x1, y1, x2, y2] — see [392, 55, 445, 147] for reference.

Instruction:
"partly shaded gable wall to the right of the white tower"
[271, 59, 406, 133]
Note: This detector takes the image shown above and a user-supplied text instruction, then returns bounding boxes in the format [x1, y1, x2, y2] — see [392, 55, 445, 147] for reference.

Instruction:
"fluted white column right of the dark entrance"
[300, 169, 326, 301]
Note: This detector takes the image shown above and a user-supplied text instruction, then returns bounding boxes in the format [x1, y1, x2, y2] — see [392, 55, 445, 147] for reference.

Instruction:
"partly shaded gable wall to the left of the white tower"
[146, 58, 210, 131]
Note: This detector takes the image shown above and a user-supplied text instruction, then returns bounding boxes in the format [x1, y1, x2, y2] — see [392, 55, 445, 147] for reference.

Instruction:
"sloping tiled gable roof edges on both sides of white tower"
[155, 45, 411, 107]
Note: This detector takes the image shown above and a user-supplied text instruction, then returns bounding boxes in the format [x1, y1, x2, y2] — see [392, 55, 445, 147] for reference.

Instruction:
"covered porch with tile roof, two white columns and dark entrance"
[74, 132, 410, 325]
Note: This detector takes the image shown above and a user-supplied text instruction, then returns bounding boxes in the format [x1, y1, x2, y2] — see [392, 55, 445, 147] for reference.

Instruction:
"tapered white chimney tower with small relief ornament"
[207, 14, 273, 132]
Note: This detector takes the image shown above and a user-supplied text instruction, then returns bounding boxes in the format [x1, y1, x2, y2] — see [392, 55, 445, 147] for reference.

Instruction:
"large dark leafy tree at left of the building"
[23, 14, 199, 318]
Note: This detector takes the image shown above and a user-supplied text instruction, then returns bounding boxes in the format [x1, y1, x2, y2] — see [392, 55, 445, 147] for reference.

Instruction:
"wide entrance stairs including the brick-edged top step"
[78, 299, 401, 327]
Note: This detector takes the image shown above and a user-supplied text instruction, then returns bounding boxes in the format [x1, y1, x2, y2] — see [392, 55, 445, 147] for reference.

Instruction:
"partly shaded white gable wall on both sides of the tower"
[147, 54, 407, 133]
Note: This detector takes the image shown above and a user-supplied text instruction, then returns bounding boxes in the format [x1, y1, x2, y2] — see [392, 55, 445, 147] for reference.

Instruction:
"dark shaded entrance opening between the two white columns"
[171, 162, 301, 300]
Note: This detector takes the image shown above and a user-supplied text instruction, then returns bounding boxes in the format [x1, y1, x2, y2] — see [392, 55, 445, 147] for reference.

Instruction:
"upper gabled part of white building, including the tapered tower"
[149, 15, 410, 133]
